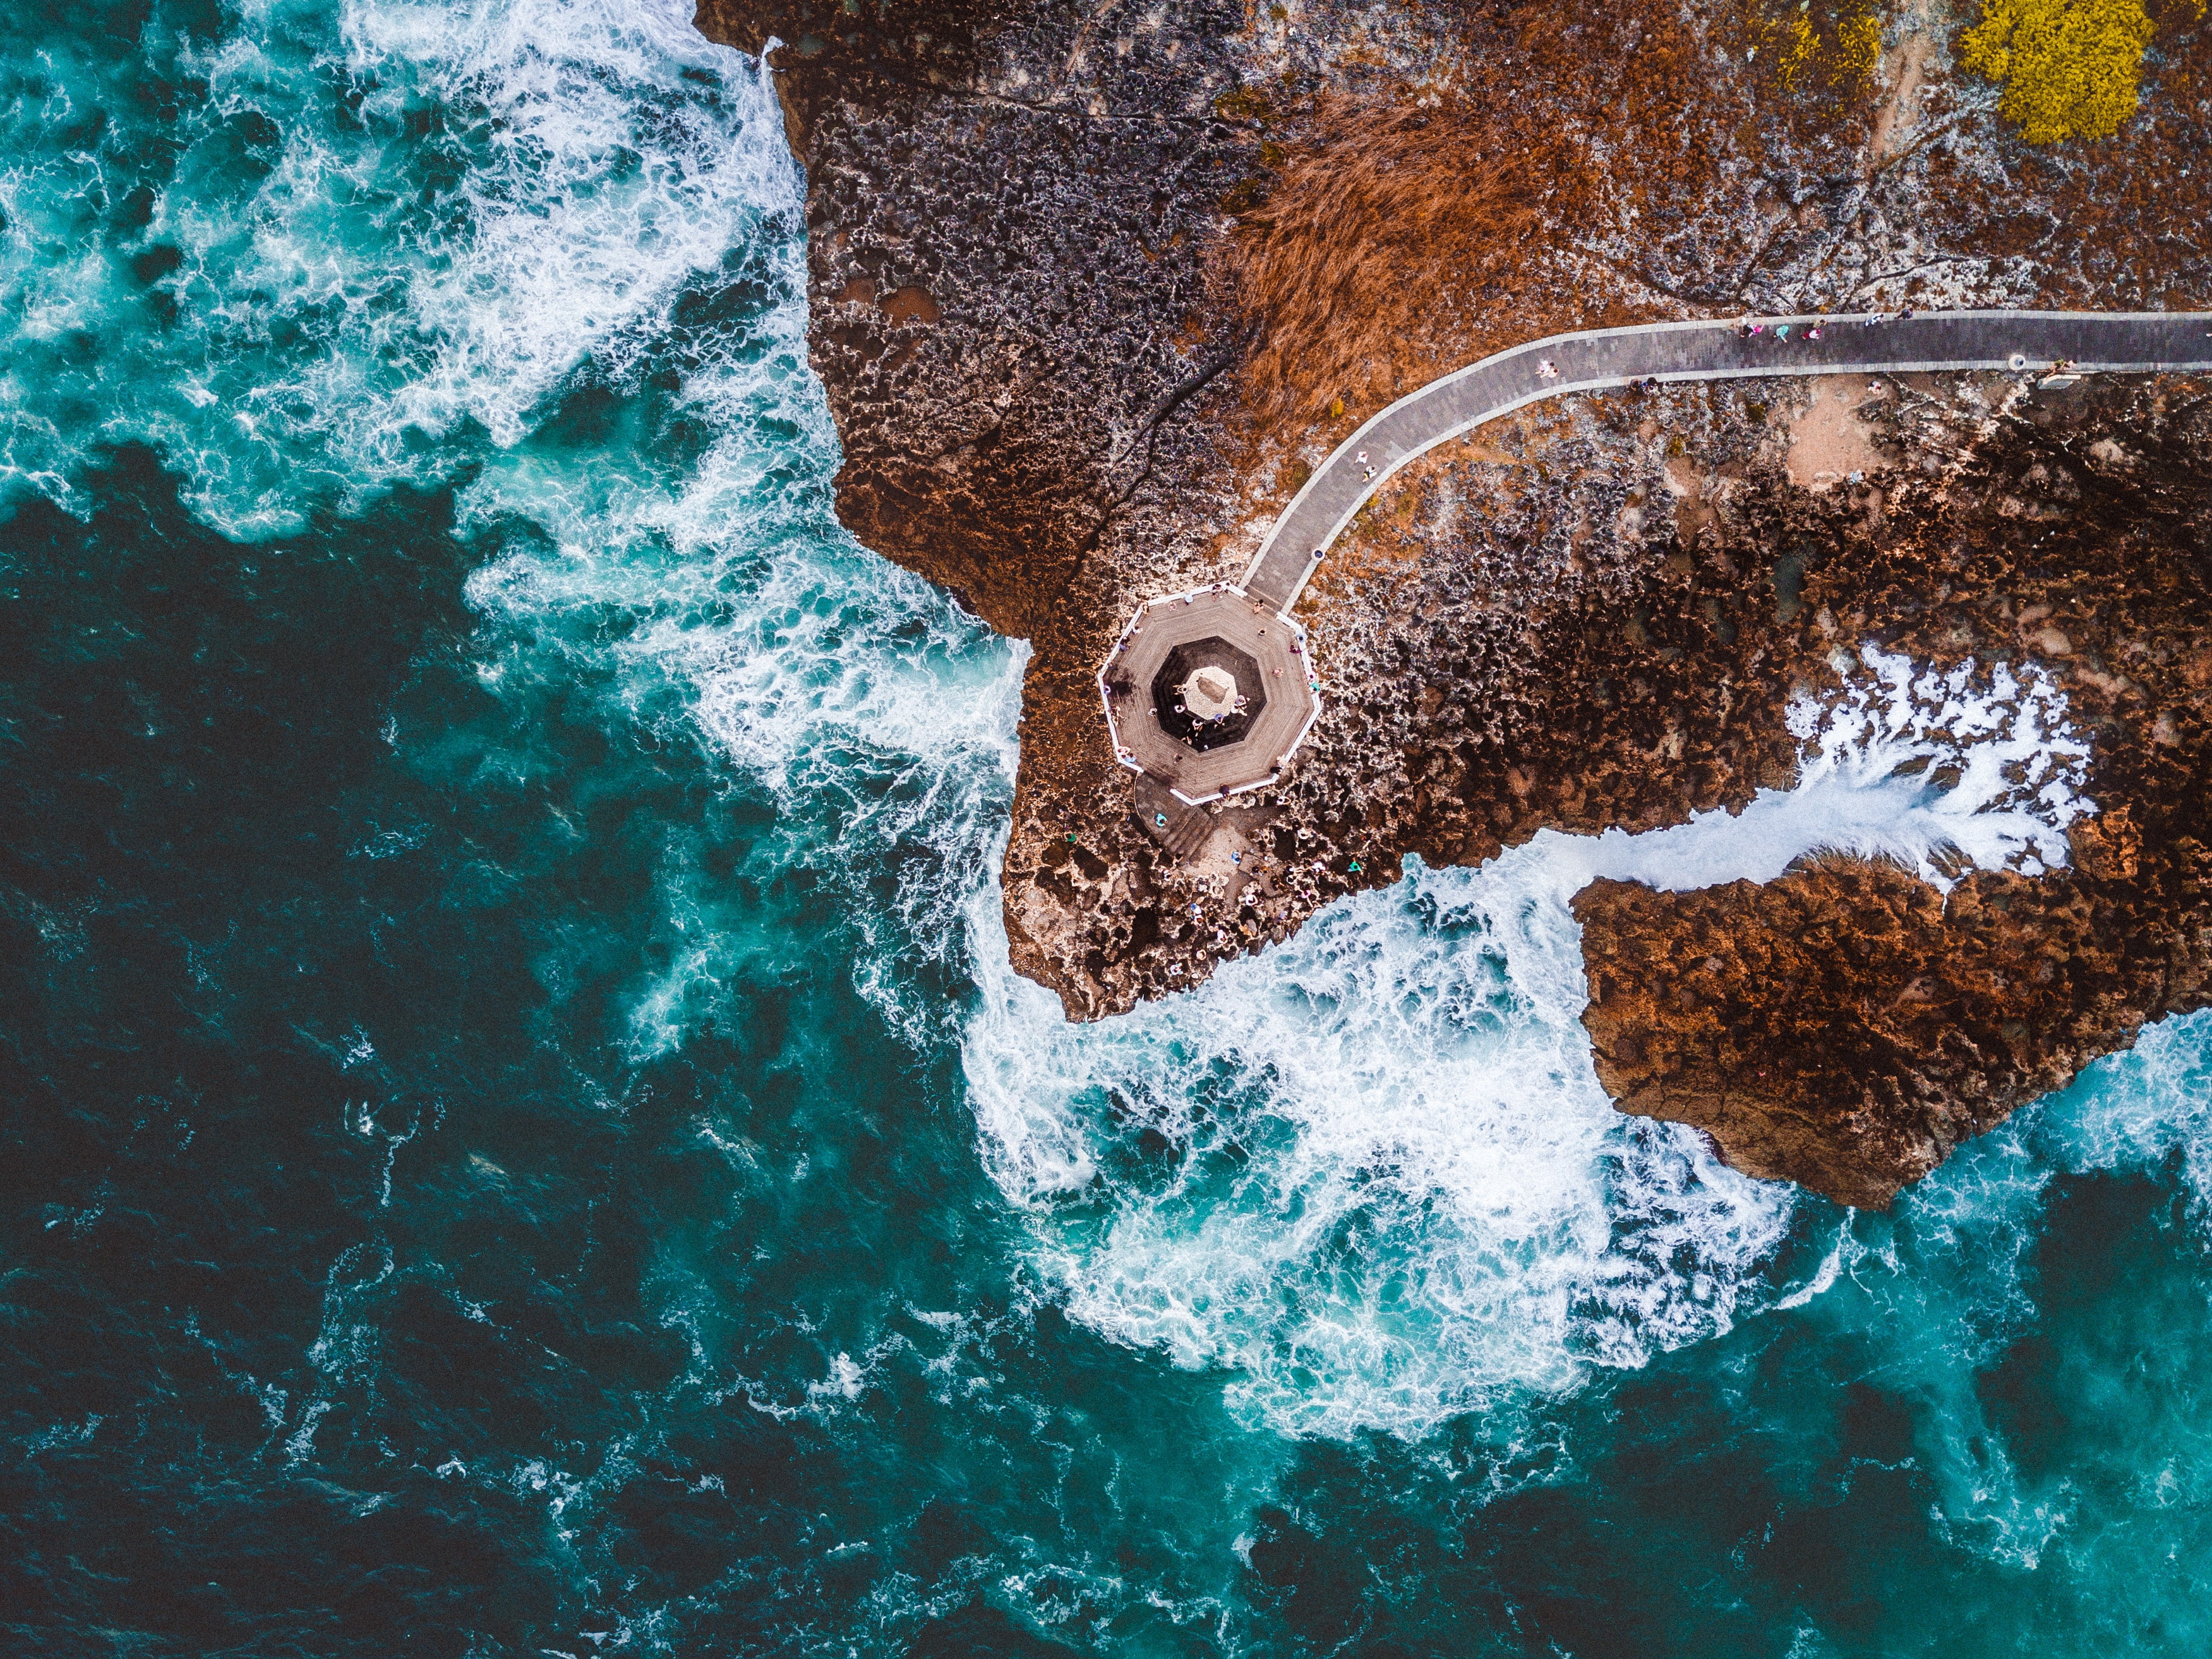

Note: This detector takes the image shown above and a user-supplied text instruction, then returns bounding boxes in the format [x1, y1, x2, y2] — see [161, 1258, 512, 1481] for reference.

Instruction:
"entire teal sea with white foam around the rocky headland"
[13, 0, 2212, 1655]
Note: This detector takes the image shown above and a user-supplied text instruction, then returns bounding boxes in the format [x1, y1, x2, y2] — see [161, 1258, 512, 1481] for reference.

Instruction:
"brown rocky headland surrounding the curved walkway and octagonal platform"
[699, 0, 2212, 1205]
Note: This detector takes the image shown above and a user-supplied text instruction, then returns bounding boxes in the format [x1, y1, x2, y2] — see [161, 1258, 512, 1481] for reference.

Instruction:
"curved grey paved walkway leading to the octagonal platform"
[1239, 312, 2212, 615]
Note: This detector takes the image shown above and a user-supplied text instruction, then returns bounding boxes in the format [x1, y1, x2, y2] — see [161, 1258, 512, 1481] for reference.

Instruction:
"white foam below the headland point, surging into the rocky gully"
[965, 650, 2088, 1435]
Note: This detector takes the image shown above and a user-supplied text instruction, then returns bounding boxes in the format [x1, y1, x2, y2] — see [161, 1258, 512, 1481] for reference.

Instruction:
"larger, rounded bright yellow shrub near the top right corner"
[1957, 0, 2150, 144]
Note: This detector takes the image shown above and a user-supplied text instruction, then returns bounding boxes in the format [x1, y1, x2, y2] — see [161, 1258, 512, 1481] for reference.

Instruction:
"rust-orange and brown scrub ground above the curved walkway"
[1215, 0, 2212, 436]
